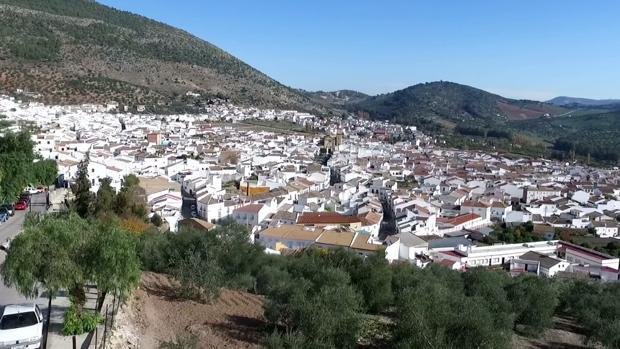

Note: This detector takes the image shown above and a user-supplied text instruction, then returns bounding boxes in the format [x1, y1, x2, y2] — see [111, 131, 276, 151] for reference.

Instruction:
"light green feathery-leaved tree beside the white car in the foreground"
[0, 213, 139, 346]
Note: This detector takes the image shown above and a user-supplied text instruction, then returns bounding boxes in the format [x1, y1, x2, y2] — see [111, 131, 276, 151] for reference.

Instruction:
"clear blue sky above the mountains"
[100, 0, 620, 100]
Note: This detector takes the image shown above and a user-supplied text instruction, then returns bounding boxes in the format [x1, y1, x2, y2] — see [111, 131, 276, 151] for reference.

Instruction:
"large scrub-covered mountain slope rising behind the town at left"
[0, 0, 321, 110]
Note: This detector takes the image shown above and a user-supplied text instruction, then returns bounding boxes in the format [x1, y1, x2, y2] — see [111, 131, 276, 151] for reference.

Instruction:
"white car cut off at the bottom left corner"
[0, 304, 43, 349]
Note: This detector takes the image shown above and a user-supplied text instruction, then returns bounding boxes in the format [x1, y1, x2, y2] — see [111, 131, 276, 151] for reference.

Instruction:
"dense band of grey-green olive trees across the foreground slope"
[132, 223, 620, 349]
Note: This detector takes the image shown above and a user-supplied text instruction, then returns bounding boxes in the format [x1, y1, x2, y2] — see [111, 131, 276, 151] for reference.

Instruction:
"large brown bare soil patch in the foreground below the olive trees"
[112, 273, 265, 349]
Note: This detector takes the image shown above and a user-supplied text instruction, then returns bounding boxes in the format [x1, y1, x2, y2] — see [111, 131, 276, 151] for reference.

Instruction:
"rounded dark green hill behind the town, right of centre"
[348, 81, 566, 130]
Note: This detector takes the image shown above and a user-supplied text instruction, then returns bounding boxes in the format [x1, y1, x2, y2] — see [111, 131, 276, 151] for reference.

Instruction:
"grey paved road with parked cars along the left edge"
[0, 194, 47, 320]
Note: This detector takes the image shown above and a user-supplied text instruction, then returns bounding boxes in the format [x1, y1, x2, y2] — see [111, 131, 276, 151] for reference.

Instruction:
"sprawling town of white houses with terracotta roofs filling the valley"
[0, 92, 620, 281]
